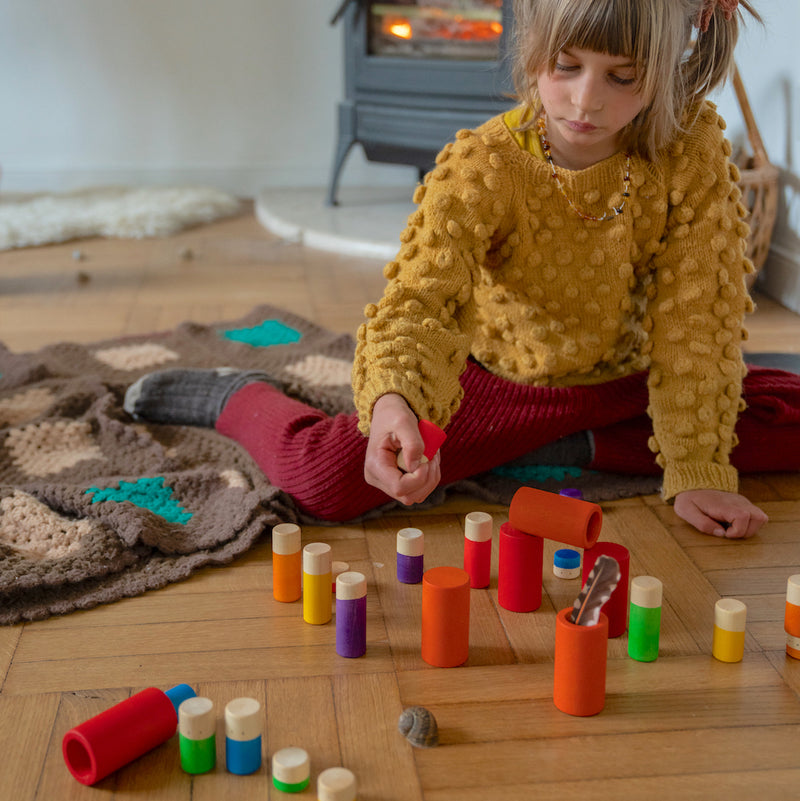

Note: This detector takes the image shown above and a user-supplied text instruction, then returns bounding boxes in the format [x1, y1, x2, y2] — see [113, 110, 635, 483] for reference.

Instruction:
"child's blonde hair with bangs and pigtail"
[513, 0, 761, 158]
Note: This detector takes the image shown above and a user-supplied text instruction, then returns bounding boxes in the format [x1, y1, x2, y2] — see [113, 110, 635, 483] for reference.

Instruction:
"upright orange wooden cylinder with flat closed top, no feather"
[422, 567, 469, 667]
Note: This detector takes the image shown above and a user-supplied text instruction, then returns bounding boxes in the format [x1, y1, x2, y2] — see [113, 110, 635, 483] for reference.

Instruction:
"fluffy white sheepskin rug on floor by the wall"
[0, 187, 240, 250]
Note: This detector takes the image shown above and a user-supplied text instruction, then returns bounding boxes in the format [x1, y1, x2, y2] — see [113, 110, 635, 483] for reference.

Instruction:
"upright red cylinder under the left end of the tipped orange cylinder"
[497, 523, 544, 612]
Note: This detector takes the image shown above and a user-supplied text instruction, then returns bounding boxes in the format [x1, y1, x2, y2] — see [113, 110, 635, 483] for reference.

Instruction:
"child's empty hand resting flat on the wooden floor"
[675, 489, 768, 539]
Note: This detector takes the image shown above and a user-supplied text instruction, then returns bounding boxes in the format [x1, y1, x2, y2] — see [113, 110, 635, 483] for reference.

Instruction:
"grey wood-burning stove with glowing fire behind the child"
[327, 0, 512, 205]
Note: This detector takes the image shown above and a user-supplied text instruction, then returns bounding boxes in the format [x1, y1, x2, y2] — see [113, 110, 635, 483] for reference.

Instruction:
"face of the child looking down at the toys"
[537, 48, 645, 169]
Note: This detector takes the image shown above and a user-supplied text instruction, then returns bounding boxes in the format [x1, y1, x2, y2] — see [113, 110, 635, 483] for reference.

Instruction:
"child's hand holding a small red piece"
[364, 394, 441, 506]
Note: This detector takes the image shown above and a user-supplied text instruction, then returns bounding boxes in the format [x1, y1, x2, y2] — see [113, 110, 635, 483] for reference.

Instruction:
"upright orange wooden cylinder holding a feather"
[553, 607, 608, 717]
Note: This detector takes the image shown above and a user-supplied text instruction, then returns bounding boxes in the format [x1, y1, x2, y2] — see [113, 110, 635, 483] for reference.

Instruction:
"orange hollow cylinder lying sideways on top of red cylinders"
[508, 487, 603, 548]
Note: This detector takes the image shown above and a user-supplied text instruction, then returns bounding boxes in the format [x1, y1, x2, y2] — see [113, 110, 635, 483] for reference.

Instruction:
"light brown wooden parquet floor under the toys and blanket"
[0, 212, 800, 801]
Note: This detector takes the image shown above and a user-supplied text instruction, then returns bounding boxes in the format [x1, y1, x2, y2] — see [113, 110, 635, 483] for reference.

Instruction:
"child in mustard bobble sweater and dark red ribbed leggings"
[126, 0, 800, 538]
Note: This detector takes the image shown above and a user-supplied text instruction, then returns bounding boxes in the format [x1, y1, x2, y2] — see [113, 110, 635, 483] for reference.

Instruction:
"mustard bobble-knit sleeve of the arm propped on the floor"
[645, 104, 753, 499]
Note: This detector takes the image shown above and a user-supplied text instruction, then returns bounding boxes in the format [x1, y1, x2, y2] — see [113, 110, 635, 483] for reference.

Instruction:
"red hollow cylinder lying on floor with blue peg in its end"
[61, 684, 195, 785]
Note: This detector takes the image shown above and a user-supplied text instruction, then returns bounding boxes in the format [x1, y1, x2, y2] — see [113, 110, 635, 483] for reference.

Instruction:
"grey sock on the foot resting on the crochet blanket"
[123, 367, 278, 428]
